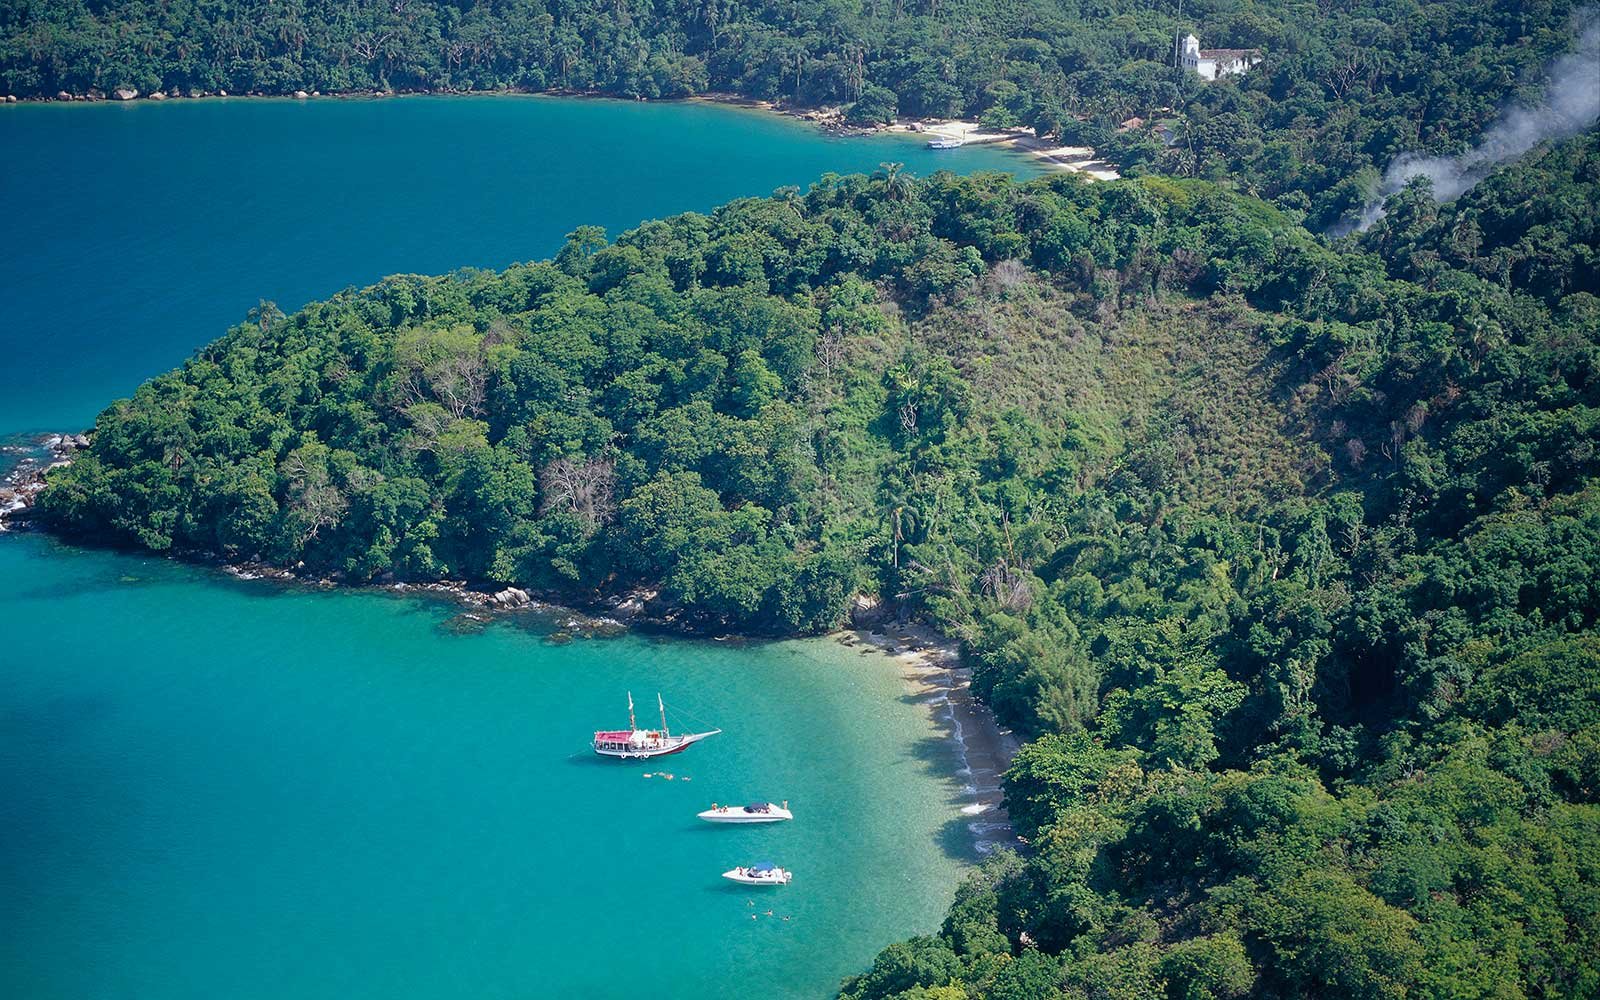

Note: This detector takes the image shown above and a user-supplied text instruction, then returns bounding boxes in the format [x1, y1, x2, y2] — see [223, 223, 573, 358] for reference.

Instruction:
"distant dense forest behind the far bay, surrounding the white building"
[0, 0, 1576, 229]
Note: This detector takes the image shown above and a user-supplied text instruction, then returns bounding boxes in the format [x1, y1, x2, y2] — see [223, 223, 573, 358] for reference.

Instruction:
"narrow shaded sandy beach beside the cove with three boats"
[834, 622, 1021, 854]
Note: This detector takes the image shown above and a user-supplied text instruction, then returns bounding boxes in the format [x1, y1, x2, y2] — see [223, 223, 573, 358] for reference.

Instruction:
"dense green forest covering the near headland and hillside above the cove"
[40, 120, 1600, 1000]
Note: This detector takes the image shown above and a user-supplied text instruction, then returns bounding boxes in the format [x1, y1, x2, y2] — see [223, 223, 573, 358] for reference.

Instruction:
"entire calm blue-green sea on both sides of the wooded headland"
[0, 98, 1034, 1000]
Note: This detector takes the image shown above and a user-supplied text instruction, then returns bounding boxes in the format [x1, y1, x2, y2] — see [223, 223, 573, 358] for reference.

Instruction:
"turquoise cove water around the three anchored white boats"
[0, 536, 966, 1000]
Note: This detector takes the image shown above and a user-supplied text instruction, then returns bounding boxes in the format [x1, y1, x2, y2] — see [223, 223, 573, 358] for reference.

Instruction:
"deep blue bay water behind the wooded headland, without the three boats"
[0, 98, 1038, 432]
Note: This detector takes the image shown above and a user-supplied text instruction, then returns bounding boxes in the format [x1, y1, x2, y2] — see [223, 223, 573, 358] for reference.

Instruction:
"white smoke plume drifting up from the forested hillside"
[1358, 6, 1600, 229]
